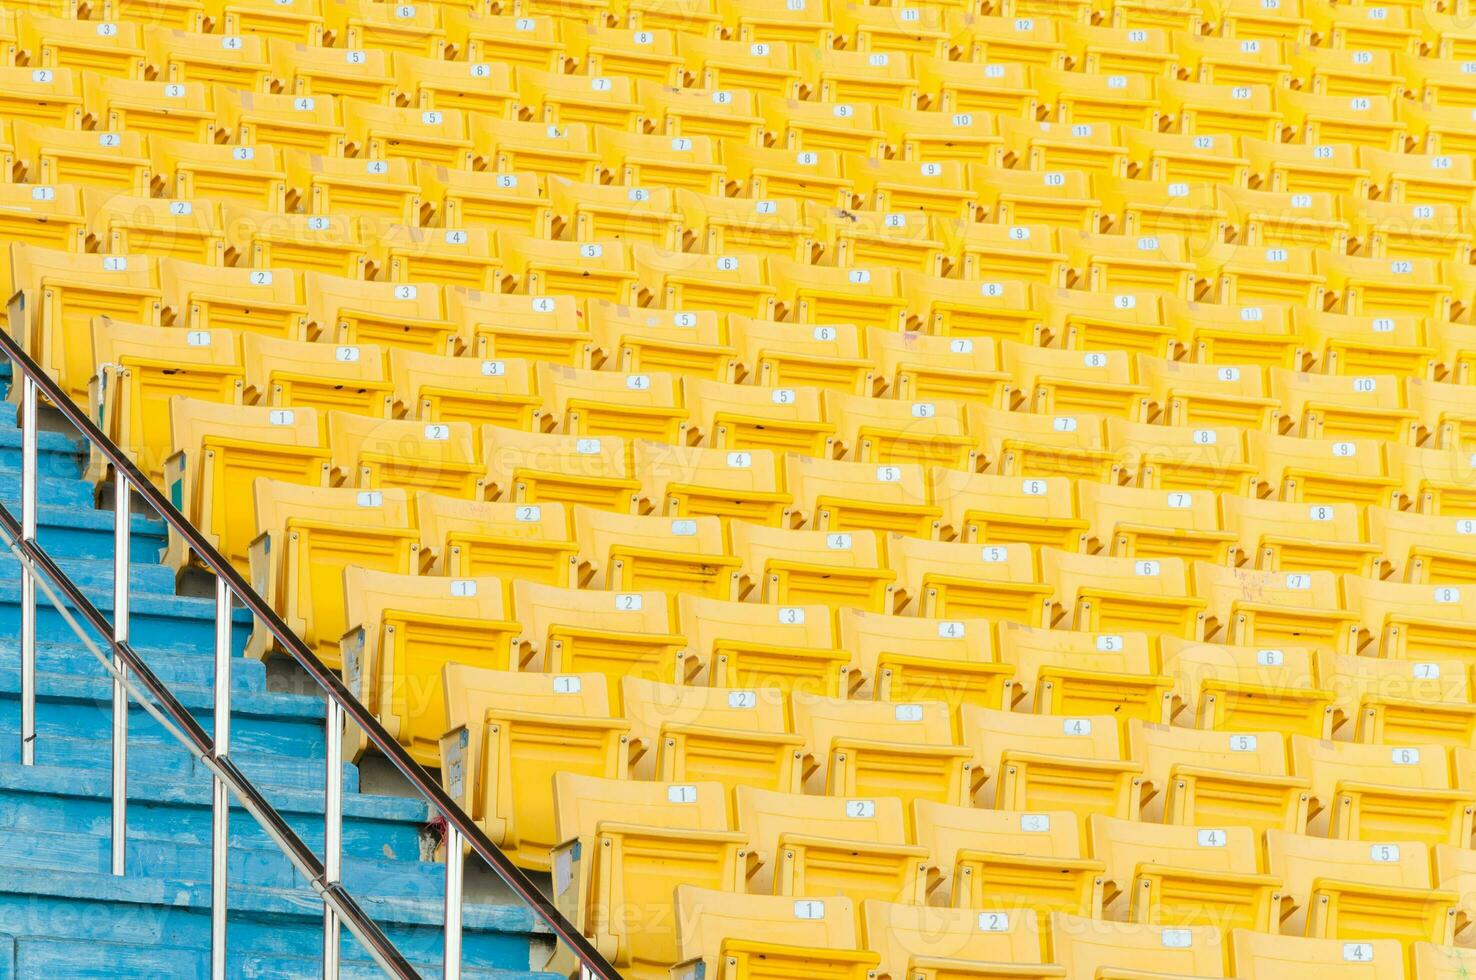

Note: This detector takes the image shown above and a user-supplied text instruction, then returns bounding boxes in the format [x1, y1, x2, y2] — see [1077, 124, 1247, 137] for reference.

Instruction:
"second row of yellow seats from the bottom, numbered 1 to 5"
[552, 767, 1473, 976]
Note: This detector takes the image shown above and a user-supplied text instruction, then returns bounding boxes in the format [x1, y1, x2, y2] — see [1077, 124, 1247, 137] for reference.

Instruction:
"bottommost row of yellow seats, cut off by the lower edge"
[673, 886, 1476, 980]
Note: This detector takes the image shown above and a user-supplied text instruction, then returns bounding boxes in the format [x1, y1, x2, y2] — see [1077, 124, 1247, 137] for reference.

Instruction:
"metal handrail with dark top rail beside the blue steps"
[0, 302, 620, 980]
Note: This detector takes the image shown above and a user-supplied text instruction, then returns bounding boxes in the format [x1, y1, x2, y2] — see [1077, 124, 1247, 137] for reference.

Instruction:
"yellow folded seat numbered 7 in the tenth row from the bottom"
[676, 190, 808, 258]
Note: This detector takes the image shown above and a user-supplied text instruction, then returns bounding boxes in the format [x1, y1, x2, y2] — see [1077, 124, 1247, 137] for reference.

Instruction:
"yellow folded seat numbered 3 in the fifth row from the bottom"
[573, 506, 738, 599]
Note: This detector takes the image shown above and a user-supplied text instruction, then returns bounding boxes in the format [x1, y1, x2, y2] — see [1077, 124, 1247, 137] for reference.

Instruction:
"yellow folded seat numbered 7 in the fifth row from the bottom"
[1194, 561, 1356, 651]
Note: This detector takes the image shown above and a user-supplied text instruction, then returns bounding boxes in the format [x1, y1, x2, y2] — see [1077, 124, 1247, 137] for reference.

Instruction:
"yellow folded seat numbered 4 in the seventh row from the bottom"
[537, 363, 686, 446]
